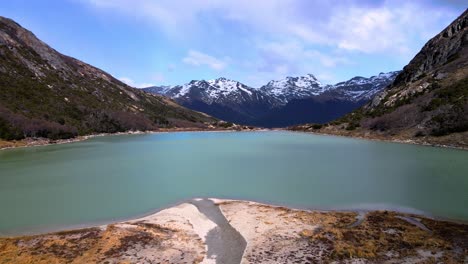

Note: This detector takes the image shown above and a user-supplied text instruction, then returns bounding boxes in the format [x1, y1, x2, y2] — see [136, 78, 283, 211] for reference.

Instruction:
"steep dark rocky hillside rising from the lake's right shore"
[296, 10, 468, 147]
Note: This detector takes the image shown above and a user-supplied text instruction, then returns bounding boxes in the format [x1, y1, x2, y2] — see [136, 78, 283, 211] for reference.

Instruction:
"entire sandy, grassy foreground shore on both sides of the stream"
[0, 199, 468, 263]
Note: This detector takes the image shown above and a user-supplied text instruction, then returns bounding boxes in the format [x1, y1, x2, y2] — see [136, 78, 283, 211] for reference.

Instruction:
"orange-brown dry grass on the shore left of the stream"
[0, 223, 203, 264]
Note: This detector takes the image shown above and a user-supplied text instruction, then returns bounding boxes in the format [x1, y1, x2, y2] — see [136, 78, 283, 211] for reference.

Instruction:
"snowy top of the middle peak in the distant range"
[260, 74, 331, 104]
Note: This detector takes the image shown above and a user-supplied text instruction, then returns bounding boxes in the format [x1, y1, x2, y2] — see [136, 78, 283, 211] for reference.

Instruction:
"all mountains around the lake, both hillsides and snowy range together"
[0, 7, 468, 147]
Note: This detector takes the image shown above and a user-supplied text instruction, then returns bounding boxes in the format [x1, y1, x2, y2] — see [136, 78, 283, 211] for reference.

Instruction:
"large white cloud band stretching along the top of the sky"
[80, 0, 456, 54]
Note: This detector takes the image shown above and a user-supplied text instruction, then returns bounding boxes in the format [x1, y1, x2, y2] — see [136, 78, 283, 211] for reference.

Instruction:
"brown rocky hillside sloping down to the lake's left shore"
[0, 17, 215, 140]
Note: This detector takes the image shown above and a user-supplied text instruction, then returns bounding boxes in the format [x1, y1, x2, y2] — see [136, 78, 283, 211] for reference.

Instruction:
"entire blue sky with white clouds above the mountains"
[0, 0, 467, 87]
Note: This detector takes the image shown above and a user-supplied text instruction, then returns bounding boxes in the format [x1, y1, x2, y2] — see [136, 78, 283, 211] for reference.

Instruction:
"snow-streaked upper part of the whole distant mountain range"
[145, 71, 399, 108]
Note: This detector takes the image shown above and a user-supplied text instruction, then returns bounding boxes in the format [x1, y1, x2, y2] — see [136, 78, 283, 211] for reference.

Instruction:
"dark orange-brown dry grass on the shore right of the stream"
[301, 212, 468, 263]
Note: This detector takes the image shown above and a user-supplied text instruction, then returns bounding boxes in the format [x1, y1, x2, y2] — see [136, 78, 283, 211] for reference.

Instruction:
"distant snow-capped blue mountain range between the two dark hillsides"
[143, 72, 398, 127]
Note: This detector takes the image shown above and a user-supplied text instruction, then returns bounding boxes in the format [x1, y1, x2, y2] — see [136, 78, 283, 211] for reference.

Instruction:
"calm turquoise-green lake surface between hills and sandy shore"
[0, 132, 468, 235]
